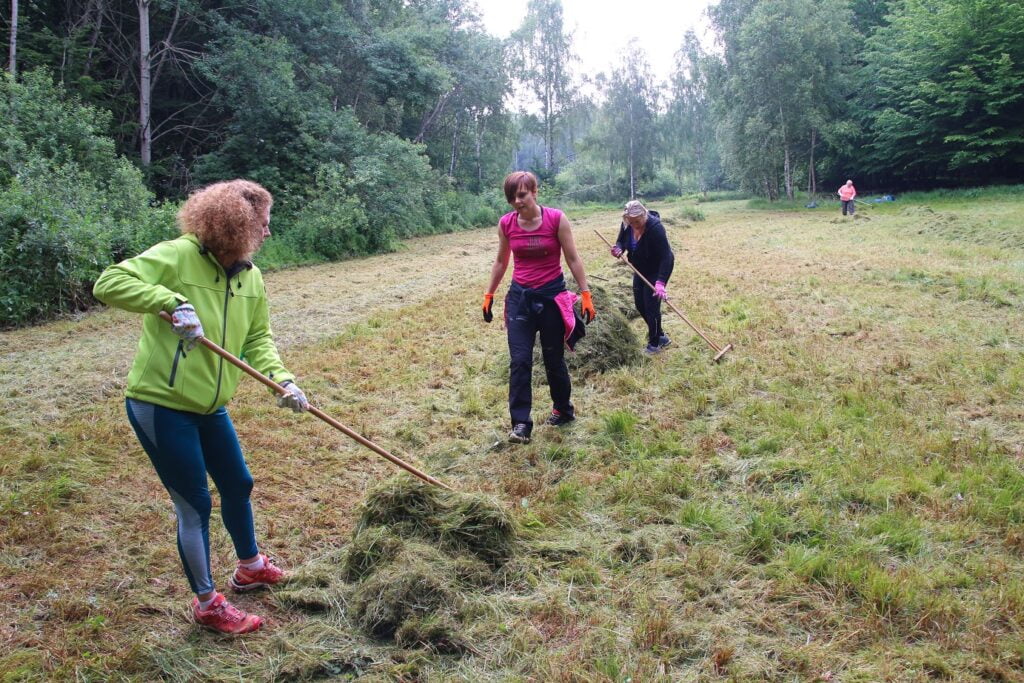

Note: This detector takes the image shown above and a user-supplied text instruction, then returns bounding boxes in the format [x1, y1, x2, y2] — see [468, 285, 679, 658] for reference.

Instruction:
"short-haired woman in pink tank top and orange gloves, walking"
[483, 171, 597, 443]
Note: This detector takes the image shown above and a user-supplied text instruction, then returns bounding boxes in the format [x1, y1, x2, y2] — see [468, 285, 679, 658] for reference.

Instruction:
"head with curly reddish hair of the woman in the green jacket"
[178, 179, 273, 263]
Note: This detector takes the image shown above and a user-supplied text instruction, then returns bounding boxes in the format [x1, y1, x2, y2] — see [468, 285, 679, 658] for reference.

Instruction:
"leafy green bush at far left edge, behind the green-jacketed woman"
[0, 71, 175, 327]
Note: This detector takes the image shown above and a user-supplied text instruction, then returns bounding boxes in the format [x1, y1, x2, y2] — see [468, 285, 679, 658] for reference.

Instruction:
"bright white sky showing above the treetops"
[476, 0, 716, 90]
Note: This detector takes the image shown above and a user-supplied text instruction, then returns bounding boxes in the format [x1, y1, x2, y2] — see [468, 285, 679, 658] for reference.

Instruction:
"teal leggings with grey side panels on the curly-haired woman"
[125, 398, 259, 595]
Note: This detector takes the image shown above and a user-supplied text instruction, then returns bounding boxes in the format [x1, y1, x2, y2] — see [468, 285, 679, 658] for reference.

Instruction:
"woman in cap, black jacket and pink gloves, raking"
[611, 200, 676, 355]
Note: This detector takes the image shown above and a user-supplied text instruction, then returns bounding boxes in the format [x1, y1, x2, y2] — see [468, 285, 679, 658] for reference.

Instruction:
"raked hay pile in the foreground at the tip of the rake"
[278, 476, 516, 652]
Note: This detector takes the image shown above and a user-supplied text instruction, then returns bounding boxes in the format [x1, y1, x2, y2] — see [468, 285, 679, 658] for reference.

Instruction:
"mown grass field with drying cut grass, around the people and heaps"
[0, 193, 1024, 681]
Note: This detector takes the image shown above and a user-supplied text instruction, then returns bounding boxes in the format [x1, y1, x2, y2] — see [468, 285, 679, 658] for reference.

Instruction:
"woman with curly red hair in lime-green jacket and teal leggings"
[93, 180, 308, 634]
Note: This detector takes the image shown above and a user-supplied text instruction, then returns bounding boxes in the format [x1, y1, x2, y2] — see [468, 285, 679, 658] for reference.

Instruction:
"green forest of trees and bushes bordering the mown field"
[0, 0, 1024, 325]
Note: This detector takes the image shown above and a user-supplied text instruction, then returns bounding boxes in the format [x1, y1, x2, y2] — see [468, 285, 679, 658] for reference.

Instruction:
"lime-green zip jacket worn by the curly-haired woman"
[92, 234, 295, 414]
